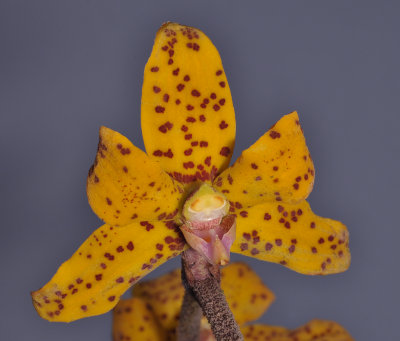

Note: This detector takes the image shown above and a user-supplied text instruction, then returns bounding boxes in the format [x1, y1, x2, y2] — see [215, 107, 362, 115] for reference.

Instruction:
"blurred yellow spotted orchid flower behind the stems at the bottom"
[113, 262, 353, 341]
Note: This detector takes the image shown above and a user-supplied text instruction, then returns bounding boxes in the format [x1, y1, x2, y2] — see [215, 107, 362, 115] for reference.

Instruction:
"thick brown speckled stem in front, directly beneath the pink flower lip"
[182, 249, 243, 341]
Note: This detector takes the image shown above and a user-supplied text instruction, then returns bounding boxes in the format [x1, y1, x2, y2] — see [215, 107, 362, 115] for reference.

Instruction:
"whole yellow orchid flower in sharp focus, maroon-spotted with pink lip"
[32, 23, 350, 322]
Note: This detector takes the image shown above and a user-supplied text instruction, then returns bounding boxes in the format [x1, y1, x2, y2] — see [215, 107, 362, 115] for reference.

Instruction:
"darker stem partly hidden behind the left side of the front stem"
[177, 290, 203, 341]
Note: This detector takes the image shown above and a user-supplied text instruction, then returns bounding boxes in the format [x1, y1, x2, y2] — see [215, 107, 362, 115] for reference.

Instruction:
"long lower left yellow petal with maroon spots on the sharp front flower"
[32, 222, 185, 322]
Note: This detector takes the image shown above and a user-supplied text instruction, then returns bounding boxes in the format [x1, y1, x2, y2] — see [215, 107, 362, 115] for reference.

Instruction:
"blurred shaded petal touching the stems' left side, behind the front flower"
[133, 269, 185, 330]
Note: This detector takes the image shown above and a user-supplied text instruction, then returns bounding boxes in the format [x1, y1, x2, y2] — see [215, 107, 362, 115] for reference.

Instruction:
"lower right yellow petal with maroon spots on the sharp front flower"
[231, 201, 350, 275]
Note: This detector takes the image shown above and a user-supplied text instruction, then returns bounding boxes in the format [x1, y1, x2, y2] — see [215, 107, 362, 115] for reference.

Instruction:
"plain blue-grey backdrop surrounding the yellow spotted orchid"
[0, 0, 400, 341]
